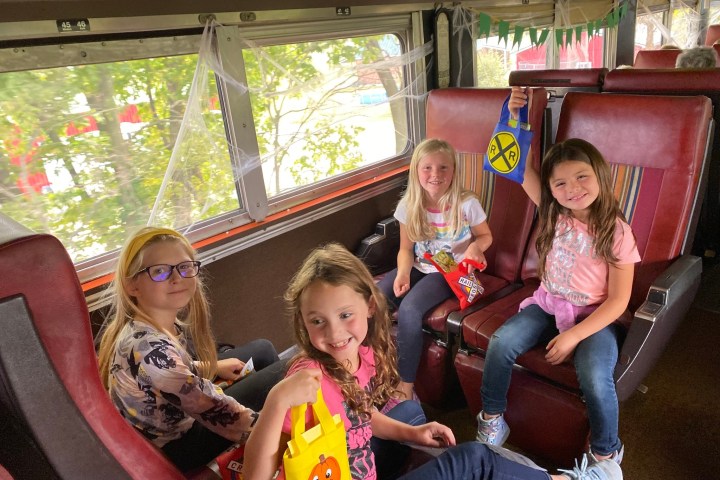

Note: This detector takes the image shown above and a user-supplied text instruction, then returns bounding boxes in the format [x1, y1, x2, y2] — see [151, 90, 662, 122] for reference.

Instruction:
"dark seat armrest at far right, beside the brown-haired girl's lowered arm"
[615, 255, 702, 401]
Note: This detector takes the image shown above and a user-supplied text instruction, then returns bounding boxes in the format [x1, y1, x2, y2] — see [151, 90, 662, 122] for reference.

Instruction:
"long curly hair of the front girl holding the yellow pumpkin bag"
[285, 243, 400, 417]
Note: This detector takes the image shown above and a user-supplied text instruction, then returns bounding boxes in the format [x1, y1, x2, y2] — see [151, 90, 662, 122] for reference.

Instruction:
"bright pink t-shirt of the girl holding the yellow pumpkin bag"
[283, 346, 377, 480]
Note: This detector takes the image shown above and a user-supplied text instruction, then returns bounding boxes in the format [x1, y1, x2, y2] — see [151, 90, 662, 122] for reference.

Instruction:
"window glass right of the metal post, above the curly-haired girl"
[243, 35, 408, 197]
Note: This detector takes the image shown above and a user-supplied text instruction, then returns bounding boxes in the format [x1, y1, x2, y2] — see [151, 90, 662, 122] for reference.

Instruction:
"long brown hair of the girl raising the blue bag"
[535, 138, 625, 278]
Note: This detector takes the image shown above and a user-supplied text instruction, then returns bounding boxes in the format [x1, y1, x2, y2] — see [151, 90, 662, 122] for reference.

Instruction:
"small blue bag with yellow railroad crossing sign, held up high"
[483, 95, 533, 183]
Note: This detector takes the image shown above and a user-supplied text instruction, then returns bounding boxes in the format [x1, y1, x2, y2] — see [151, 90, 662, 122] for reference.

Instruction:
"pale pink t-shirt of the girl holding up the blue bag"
[542, 215, 640, 306]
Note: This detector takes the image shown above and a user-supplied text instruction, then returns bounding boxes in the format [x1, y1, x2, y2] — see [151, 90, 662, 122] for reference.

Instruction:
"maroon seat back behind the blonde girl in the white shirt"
[426, 88, 547, 283]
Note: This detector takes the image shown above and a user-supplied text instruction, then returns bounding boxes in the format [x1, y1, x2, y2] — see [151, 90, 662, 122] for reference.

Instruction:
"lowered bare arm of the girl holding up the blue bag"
[545, 263, 635, 365]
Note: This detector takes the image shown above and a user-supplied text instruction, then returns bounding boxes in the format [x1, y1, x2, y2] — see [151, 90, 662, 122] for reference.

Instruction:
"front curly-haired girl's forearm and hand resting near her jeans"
[371, 411, 455, 447]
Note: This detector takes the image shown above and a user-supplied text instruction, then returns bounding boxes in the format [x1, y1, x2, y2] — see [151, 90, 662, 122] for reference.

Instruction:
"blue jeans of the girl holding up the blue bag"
[480, 305, 620, 455]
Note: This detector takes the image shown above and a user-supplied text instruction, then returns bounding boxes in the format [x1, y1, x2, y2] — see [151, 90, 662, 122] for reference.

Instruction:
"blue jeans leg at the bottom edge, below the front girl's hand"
[400, 442, 550, 480]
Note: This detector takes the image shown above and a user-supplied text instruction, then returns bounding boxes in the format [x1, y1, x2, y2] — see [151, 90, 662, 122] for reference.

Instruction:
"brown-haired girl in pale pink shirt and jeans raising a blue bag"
[477, 87, 640, 463]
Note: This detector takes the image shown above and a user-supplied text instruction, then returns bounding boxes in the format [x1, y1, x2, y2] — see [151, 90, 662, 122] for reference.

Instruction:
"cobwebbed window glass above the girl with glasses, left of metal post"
[0, 55, 240, 262]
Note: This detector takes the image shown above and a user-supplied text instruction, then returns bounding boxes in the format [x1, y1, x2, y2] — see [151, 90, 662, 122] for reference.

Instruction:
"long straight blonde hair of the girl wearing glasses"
[98, 227, 217, 388]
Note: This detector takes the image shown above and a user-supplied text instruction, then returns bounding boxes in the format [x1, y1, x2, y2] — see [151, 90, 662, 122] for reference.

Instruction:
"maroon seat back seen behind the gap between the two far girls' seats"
[509, 68, 608, 144]
